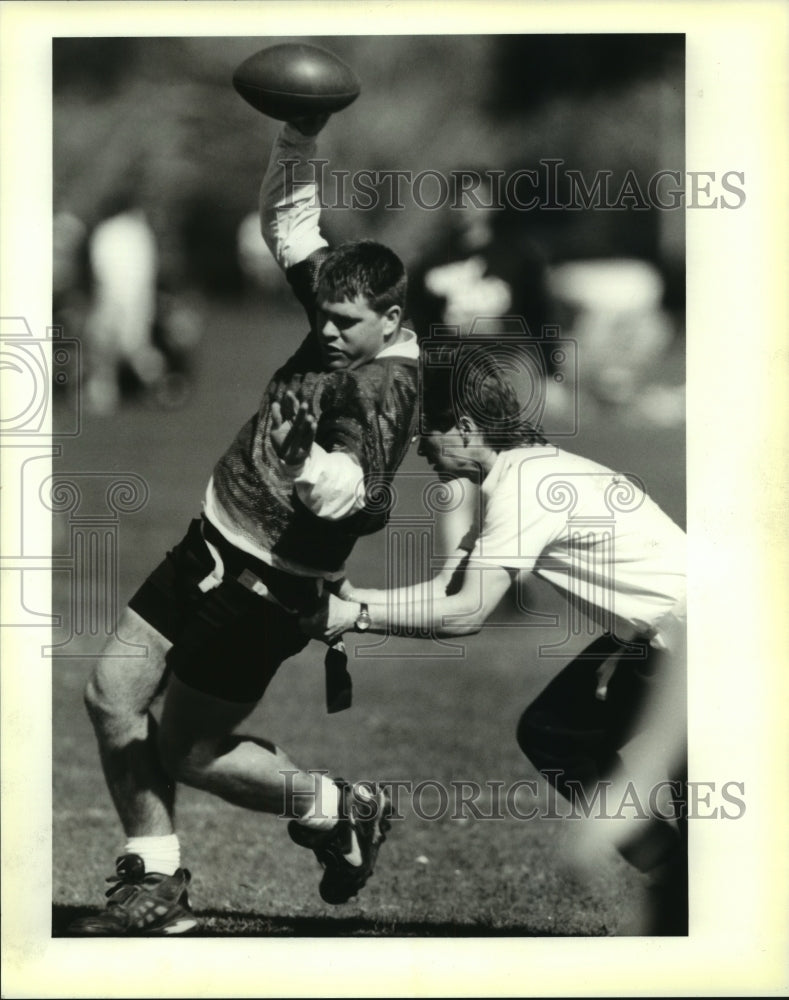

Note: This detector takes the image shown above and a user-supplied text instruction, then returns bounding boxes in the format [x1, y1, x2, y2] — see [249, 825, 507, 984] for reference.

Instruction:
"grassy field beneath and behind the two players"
[53, 292, 685, 937]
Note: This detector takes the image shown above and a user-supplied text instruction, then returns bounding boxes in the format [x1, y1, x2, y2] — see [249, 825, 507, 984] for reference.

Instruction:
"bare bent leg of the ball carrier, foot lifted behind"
[161, 678, 326, 816]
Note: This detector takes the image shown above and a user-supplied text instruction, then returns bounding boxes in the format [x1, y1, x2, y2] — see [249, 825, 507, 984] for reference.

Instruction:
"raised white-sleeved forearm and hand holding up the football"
[260, 115, 328, 271]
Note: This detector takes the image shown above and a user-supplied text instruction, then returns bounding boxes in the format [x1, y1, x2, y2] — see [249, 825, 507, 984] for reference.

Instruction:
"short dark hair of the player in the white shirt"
[421, 344, 547, 451]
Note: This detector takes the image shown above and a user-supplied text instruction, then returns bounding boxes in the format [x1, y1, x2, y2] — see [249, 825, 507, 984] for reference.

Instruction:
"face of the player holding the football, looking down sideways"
[317, 295, 400, 371]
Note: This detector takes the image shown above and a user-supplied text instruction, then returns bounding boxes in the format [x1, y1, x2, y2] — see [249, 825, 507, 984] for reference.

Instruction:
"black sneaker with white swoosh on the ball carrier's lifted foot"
[288, 780, 392, 905]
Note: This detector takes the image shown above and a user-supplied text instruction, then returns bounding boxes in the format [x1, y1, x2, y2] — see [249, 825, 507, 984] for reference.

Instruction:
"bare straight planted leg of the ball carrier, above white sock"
[85, 608, 175, 837]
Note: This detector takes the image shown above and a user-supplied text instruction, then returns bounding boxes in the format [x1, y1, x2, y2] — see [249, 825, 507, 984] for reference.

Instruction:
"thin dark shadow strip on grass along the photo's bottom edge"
[52, 905, 607, 938]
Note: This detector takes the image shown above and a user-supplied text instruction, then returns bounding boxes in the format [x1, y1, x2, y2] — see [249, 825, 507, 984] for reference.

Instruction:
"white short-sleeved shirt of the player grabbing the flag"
[462, 445, 686, 630]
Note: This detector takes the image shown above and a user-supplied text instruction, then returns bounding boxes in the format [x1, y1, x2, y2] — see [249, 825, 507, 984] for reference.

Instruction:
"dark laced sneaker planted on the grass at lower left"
[69, 854, 197, 937]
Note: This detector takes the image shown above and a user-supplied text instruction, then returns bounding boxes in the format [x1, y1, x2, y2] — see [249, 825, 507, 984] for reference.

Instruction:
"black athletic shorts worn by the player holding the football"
[129, 518, 320, 702]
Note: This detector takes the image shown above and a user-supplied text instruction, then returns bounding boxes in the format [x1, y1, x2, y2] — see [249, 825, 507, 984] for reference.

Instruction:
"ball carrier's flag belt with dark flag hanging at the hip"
[198, 517, 353, 713]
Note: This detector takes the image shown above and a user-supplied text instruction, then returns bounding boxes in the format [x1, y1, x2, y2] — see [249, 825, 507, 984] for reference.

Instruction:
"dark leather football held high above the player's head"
[233, 44, 361, 121]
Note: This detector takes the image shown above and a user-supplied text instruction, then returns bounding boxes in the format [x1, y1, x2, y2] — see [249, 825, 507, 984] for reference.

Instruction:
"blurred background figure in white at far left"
[84, 194, 167, 414]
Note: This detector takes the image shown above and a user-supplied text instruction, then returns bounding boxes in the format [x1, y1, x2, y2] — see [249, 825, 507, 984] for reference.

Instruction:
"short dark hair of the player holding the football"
[317, 240, 408, 313]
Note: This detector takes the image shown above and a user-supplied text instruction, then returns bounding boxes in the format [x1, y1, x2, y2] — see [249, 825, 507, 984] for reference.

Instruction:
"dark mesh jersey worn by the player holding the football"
[208, 249, 418, 574]
